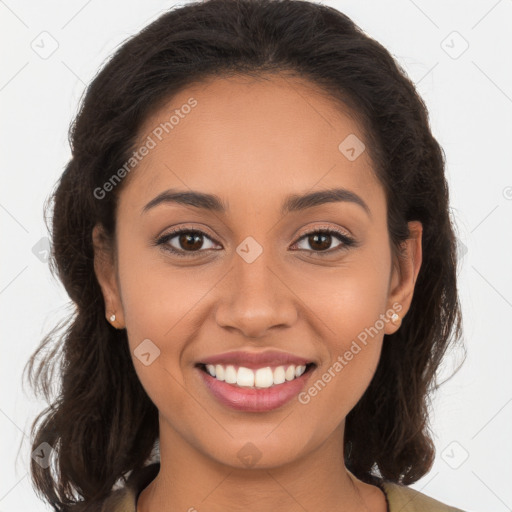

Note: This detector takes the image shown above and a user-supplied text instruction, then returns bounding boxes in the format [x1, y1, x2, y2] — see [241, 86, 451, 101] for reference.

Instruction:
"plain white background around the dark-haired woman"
[0, 0, 512, 512]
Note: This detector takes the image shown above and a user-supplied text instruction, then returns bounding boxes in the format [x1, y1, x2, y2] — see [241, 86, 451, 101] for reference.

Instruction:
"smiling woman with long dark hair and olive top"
[26, 0, 461, 512]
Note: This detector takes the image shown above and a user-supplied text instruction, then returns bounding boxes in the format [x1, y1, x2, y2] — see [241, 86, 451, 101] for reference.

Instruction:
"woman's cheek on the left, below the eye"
[115, 242, 195, 408]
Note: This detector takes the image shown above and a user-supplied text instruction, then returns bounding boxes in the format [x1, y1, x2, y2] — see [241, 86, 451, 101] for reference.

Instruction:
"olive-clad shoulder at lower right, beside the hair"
[380, 481, 464, 512]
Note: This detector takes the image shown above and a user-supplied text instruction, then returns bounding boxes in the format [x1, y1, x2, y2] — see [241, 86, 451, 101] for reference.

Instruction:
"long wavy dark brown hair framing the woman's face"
[25, 0, 462, 511]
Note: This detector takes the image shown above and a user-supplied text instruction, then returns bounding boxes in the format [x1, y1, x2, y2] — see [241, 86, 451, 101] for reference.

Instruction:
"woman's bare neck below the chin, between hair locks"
[137, 419, 386, 512]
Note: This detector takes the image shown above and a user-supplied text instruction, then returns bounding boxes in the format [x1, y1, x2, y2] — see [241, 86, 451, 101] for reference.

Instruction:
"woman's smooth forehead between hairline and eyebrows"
[122, 76, 379, 213]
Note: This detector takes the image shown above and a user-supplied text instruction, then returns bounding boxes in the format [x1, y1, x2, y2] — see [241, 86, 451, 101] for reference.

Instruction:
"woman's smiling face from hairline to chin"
[94, 77, 421, 467]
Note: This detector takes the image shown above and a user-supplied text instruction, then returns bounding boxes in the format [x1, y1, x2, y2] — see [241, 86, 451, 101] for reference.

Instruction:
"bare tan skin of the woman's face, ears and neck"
[93, 76, 422, 512]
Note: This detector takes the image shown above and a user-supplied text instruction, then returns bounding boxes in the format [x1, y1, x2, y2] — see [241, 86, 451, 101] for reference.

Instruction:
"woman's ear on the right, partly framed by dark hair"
[384, 220, 423, 334]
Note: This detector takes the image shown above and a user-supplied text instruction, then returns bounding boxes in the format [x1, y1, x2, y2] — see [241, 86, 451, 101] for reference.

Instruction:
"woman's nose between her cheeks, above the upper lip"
[215, 251, 297, 338]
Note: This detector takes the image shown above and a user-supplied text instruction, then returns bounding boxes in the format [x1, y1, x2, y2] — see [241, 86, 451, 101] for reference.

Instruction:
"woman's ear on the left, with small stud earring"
[92, 224, 125, 329]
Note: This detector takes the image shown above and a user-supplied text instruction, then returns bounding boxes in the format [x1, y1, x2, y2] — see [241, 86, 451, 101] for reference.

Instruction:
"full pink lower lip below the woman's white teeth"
[197, 367, 315, 412]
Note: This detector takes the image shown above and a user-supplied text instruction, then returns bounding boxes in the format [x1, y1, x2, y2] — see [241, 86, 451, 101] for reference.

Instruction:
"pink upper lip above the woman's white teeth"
[198, 350, 313, 369]
